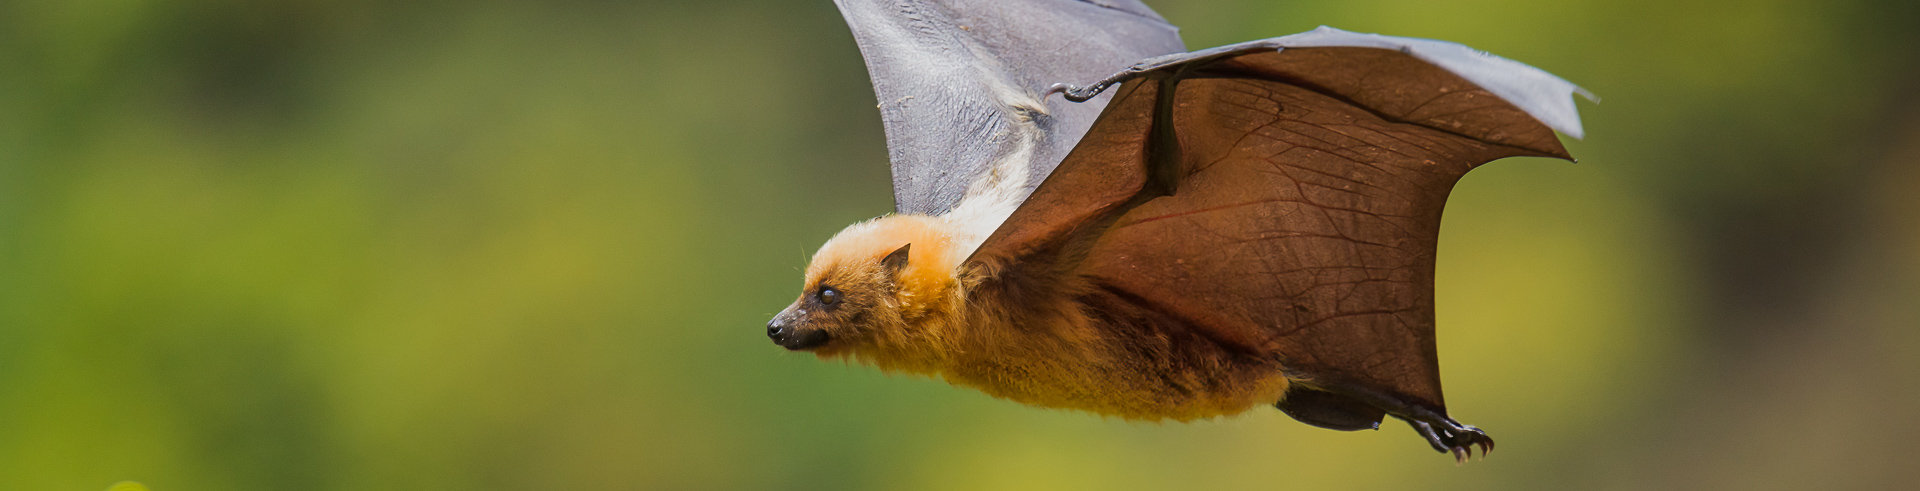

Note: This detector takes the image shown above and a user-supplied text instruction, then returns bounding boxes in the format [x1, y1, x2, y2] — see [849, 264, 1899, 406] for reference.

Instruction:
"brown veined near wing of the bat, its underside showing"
[975, 48, 1567, 414]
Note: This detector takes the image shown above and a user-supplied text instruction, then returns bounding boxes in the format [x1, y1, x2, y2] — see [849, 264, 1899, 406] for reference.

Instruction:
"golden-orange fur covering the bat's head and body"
[789, 215, 1288, 420]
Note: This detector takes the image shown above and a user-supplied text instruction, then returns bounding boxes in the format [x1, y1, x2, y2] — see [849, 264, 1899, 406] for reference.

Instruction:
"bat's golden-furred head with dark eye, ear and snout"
[766, 215, 960, 364]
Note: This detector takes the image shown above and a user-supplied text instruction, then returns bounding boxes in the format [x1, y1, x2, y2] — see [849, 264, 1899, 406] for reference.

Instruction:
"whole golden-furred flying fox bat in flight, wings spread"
[768, 0, 1584, 460]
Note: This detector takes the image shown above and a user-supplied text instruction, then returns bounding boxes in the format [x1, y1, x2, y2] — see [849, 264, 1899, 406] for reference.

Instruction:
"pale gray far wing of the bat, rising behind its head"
[835, 0, 1187, 215]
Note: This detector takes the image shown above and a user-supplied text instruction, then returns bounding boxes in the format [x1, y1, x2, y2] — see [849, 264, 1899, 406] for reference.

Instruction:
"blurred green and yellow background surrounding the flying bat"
[0, 0, 1920, 491]
